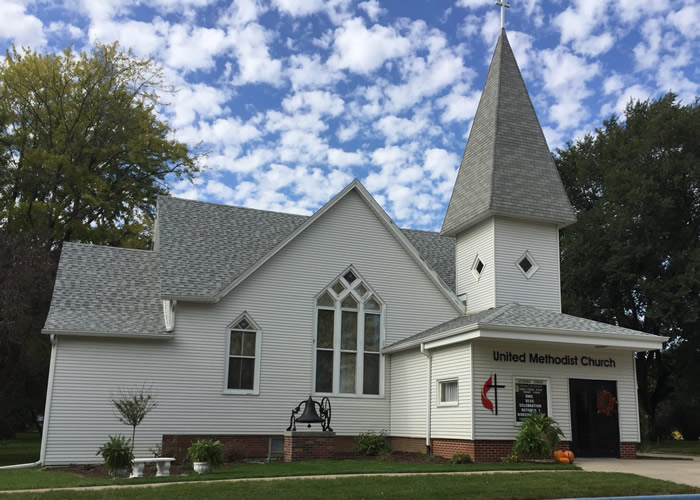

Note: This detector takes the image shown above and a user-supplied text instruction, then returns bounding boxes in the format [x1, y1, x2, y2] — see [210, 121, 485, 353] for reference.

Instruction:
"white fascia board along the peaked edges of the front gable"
[213, 179, 464, 314]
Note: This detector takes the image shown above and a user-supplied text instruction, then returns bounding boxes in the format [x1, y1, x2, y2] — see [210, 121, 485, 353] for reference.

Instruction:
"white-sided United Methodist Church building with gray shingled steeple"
[41, 30, 668, 465]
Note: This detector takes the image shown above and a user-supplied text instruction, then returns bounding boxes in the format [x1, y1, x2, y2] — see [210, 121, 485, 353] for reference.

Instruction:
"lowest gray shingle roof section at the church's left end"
[44, 243, 165, 335]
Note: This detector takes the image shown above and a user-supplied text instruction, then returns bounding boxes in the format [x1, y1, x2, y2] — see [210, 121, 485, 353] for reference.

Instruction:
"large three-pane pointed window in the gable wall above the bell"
[314, 267, 384, 396]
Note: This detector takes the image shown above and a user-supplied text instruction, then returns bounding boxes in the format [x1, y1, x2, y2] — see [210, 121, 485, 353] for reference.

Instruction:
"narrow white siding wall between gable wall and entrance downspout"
[390, 349, 428, 437]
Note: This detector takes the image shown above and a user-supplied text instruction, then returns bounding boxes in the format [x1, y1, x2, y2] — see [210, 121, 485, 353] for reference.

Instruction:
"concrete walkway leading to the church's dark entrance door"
[575, 455, 700, 488]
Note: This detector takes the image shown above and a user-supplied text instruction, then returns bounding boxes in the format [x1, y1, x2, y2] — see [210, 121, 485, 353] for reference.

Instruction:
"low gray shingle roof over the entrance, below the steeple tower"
[387, 304, 660, 350]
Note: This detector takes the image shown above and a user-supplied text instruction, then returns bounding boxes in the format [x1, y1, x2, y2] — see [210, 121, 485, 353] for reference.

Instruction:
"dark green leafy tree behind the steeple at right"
[555, 93, 700, 436]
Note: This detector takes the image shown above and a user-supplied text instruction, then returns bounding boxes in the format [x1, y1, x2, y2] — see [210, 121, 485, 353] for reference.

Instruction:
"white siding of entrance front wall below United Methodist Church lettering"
[472, 341, 639, 442]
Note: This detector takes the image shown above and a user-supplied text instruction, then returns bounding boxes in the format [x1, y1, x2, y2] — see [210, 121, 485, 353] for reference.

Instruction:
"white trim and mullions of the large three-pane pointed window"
[311, 265, 386, 399]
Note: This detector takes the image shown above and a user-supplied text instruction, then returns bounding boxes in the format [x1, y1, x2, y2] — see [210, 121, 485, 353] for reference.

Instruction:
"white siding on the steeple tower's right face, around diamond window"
[495, 217, 561, 312]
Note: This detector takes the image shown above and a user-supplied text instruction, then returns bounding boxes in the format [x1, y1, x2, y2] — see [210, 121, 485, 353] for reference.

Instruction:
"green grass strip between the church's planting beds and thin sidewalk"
[0, 460, 577, 490]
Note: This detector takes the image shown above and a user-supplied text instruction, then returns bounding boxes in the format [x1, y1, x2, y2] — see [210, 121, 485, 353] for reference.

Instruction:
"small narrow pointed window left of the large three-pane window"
[224, 313, 262, 394]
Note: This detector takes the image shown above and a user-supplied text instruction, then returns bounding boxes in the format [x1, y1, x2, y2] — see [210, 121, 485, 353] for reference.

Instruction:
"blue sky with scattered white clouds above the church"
[0, 0, 700, 230]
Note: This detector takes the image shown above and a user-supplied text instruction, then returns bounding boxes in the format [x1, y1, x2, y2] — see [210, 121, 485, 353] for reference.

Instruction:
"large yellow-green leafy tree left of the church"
[0, 43, 198, 437]
